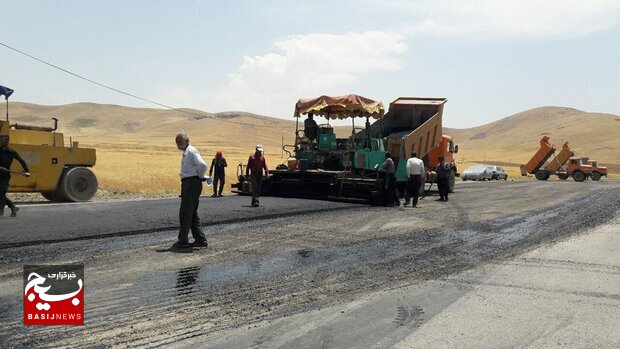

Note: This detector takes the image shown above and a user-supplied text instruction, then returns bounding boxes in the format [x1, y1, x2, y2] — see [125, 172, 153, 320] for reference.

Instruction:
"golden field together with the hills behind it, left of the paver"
[9, 102, 295, 194]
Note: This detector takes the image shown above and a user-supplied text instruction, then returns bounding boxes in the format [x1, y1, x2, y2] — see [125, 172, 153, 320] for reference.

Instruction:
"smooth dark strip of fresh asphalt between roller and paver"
[0, 195, 359, 249]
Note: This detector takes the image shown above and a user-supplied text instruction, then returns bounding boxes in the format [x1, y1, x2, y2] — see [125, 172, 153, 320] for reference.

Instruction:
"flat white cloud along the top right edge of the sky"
[371, 0, 620, 40]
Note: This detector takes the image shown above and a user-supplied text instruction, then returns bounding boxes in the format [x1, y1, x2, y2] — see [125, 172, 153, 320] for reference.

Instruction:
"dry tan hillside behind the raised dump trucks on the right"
[444, 107, 620, 173]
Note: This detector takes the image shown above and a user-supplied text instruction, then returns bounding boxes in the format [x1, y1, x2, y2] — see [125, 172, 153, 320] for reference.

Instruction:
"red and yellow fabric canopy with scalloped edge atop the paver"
[295, 94, 384, 119]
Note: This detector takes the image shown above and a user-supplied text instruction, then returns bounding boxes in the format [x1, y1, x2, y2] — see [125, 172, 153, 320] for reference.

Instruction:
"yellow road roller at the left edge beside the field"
[0, 86, 98, 202]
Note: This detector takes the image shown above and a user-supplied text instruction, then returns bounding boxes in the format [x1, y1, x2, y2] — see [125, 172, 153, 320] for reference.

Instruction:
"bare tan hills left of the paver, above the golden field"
[10, 103, 295, 153]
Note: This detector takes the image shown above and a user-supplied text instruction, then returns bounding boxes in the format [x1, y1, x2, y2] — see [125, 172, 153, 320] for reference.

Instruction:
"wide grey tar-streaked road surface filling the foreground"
[0, 180, 620, 348]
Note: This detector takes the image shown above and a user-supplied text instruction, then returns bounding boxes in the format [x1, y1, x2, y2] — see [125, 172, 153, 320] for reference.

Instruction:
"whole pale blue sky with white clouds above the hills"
[0, 0, 620, 128]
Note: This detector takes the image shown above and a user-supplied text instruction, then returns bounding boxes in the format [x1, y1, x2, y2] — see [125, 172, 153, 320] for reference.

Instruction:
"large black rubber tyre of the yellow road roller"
[58, 167, 99, 202]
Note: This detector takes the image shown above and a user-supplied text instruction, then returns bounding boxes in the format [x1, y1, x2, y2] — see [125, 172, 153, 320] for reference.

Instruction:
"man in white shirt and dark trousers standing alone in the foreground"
[172, 131, 207, 248]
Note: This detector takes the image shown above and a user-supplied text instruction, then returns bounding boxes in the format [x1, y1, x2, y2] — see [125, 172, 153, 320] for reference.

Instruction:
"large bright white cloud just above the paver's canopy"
[210, 31, 407, 116]
